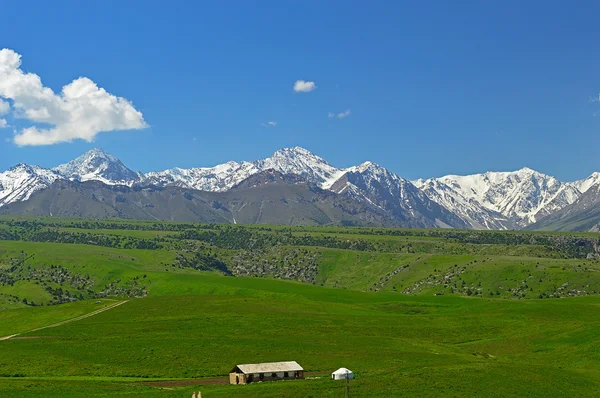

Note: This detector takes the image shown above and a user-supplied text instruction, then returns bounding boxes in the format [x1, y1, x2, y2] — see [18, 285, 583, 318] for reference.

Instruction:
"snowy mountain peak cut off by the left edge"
[0, 164, 61, 206]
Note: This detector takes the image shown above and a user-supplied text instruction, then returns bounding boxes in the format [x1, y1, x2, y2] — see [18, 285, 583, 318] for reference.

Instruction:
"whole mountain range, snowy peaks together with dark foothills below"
[0, 147, 600, 231]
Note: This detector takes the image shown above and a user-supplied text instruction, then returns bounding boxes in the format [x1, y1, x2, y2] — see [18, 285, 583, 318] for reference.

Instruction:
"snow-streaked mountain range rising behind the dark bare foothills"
[0, 147, 600, 229]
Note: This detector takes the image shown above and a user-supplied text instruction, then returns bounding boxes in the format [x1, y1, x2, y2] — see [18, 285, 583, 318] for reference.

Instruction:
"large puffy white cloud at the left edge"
[0, 48, 148, 146]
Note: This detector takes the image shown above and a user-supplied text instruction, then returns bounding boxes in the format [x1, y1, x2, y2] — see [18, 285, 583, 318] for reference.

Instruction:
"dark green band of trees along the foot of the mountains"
[0, 219, 600, 258]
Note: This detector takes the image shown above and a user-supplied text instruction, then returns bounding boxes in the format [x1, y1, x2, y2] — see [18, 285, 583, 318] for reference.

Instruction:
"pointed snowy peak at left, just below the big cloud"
[53, 148, 140, 185]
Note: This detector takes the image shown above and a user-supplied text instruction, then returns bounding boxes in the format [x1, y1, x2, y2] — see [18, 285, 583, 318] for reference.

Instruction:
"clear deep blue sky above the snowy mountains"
[0, 0, 600, 180]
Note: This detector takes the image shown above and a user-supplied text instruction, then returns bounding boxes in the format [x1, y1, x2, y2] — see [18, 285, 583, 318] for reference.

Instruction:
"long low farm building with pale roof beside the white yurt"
[229, 361, 304, 384]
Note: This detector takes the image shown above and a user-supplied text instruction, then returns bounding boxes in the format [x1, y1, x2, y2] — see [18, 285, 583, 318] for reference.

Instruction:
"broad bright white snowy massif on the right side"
[416, 167, 580, 228]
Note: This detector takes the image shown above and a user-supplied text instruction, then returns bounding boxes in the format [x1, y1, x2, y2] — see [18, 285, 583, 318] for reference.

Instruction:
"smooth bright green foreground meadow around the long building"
[0, 278, 600, 397]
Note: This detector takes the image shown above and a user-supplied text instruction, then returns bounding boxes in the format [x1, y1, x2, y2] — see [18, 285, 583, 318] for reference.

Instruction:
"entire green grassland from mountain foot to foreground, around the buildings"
[0, 219, 600, 397]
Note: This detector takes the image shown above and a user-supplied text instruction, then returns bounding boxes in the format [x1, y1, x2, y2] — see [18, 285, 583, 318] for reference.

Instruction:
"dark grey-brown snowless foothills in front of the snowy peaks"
[0, 172, 398, 226]
